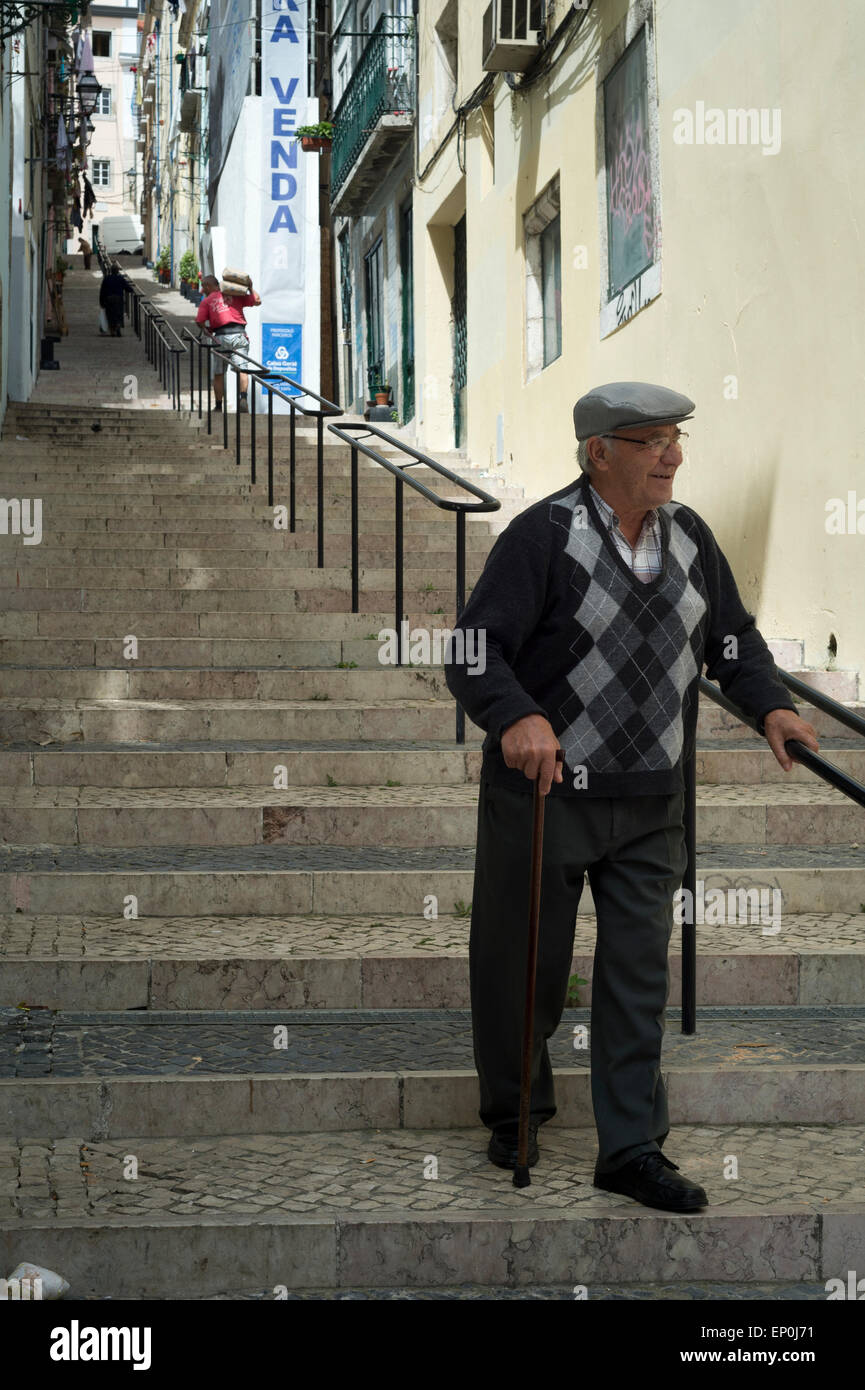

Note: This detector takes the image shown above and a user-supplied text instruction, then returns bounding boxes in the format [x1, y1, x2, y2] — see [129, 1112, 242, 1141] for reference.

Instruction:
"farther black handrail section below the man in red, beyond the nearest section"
[184, 328, 342, 550]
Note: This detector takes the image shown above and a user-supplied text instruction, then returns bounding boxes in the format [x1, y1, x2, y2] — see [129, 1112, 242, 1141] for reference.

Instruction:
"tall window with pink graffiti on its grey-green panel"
[604, 28, 655, 299]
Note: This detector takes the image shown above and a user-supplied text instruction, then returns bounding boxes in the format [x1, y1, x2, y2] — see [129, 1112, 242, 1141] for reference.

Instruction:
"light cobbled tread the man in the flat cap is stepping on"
[0, 1125, 865, 1225]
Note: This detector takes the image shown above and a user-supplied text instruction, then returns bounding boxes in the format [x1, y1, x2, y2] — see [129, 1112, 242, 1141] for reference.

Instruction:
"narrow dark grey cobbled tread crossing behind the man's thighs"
[0, 844, 865, 873]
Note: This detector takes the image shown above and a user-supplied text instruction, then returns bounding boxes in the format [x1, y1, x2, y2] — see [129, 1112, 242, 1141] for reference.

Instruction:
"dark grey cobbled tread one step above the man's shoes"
[0, 1006, 865, 1077]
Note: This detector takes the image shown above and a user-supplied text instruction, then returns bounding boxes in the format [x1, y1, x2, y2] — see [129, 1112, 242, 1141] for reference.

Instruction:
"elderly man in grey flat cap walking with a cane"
[445, 382, 818, 1212]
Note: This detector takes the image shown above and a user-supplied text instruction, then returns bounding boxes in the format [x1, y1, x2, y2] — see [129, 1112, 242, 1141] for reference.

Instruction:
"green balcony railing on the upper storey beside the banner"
[331, 14, 414, 200]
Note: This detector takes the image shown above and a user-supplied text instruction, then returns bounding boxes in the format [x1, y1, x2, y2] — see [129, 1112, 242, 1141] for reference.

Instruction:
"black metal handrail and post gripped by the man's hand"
[681, 666, 865, 1033]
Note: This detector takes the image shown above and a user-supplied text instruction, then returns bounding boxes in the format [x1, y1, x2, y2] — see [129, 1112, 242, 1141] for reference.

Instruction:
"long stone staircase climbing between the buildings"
[0, 273, 865, 1300]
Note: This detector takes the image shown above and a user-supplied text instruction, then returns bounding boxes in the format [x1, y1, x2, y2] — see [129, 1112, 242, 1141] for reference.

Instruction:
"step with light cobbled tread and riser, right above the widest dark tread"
[0, 908, 865, 1011]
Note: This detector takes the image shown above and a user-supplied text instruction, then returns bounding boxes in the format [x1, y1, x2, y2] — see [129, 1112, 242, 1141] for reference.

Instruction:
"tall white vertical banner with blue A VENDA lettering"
[257, 0, 321, 413]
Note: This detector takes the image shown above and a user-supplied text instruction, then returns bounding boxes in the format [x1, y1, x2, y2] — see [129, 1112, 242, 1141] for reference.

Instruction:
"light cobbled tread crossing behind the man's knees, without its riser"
[0, 912, 865, 960]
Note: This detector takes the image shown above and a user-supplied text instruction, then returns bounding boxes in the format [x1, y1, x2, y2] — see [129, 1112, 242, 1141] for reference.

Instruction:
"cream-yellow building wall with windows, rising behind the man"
[408, 0, 865, 667]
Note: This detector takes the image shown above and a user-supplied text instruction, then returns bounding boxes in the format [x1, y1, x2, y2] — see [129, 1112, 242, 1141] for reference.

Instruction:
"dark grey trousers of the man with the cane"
[469, 780, 686, 1172]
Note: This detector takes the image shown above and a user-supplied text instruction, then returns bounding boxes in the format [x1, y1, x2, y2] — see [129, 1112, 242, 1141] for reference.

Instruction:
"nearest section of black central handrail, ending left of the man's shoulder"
[327, 421, 502, 744]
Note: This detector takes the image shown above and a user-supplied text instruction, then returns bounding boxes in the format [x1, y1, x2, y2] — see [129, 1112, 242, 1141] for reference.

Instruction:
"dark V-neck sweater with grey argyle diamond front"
[445, 474, 795, 796]
